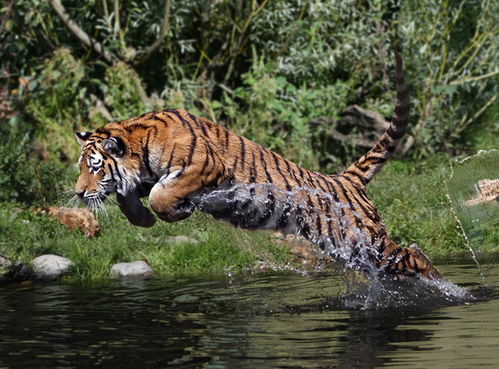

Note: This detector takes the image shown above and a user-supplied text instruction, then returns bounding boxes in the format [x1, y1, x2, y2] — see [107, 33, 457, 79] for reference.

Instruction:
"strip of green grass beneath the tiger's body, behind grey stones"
[0, 203, 289, 279]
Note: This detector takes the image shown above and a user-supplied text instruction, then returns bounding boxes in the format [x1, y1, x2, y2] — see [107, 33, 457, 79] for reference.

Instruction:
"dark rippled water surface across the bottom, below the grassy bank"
[0, 265, 499, 369]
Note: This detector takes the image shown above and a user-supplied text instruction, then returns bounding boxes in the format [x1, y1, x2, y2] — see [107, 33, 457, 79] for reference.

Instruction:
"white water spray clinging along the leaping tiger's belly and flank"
[192, 183, 379, 274]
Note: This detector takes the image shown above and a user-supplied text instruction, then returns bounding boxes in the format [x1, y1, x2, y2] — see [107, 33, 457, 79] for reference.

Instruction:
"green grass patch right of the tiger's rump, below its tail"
[368, 154, 499, 263]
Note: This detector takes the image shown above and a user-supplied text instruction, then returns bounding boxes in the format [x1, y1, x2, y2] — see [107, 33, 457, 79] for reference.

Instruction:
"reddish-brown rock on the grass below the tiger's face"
[32, 206, 100, 238]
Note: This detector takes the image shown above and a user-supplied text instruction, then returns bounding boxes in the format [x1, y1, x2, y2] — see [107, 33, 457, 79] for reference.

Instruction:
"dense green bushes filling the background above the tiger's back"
[0, 0, 499, 172]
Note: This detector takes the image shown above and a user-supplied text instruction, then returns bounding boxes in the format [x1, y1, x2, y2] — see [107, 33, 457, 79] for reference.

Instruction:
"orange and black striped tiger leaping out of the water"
[75, 53, 442, 280]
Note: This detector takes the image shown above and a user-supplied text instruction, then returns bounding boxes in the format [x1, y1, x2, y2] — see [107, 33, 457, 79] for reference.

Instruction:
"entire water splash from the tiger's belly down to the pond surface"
[192, 178, 473, 309]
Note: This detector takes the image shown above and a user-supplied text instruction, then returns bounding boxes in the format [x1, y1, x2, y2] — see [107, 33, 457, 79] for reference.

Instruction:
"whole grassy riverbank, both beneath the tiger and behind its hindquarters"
[0, 155, 499, 279]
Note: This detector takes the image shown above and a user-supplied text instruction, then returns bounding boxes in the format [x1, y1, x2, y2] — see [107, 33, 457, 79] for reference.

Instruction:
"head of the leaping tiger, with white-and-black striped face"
[75, 130, 138, 209]
